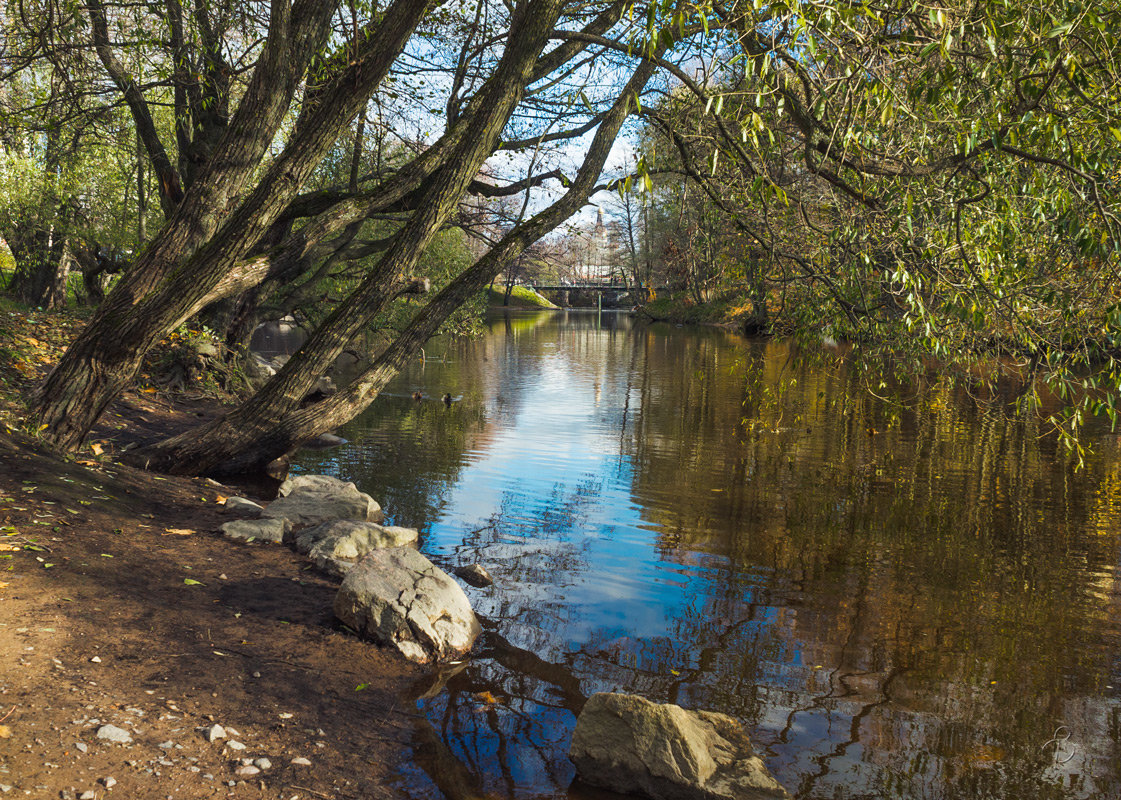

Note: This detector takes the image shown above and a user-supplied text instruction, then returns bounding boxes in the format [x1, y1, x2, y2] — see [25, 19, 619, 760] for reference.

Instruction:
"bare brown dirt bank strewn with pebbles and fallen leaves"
[0, 432, 419, 800]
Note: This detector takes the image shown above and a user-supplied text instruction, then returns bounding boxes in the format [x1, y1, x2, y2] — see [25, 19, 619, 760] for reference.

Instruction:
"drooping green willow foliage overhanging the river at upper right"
[645, 0, 1121, 447]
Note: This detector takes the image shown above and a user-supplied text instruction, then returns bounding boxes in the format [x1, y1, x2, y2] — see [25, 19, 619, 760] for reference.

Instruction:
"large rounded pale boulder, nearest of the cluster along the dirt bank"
[335, 547, 482, 663]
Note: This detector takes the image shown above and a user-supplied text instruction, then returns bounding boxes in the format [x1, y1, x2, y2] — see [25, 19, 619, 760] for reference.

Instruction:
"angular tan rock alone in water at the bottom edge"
[568, 692, 790, 800]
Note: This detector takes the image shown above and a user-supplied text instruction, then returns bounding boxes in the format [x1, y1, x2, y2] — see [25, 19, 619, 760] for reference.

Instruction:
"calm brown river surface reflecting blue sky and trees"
[282, 311, 1121, 800]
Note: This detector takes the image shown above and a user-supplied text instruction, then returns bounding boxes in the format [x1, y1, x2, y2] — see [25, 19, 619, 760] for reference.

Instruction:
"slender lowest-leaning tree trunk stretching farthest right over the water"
[128, 48, 664, 474]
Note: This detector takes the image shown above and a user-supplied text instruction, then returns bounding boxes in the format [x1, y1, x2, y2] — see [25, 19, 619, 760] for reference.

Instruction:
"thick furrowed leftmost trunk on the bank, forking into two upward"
[36, 0, 427, 449]
